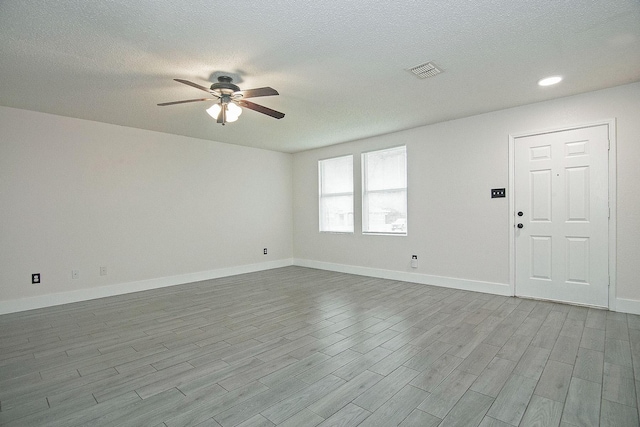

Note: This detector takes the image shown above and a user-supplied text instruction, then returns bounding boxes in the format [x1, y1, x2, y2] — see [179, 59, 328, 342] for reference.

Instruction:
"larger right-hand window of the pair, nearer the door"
[362, 146, 407, 235]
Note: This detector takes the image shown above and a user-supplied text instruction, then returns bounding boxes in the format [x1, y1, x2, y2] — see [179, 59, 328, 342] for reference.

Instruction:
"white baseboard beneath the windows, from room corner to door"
[293, 258, 511, 296]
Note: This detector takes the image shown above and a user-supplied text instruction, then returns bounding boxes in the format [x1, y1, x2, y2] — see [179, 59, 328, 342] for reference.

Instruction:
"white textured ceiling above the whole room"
[0, 0, 640, 152]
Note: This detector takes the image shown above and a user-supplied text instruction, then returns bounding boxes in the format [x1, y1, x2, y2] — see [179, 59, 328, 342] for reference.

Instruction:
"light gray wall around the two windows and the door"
[293, 83, 640, 309]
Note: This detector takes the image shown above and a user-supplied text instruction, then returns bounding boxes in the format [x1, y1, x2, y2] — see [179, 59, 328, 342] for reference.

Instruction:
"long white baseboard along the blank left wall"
[0, 258, 293, 314]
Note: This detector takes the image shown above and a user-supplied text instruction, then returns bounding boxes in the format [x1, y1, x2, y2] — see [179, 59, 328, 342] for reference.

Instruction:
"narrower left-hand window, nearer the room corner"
[318, 155, 353, 233]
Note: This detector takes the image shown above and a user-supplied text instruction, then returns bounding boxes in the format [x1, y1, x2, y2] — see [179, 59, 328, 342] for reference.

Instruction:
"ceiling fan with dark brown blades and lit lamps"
[158, 76, 284, 125]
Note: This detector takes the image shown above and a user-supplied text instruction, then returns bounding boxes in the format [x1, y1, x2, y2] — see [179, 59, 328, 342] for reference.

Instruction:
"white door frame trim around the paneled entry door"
[507, 118, 618, 311]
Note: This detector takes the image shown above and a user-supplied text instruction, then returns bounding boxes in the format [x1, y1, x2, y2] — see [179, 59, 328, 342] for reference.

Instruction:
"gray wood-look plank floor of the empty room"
[0, 267, 640, 427]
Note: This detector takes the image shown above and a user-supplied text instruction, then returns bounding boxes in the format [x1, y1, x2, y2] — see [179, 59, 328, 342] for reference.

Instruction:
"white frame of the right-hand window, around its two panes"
[360, 145, 409, 237]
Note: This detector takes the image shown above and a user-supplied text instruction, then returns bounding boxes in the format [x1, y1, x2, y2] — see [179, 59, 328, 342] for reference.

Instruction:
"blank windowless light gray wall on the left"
[0, 107, 292, 312]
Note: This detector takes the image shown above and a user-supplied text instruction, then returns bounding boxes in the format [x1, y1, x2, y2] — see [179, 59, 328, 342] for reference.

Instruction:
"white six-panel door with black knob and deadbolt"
[514, 125, 609, 307]
